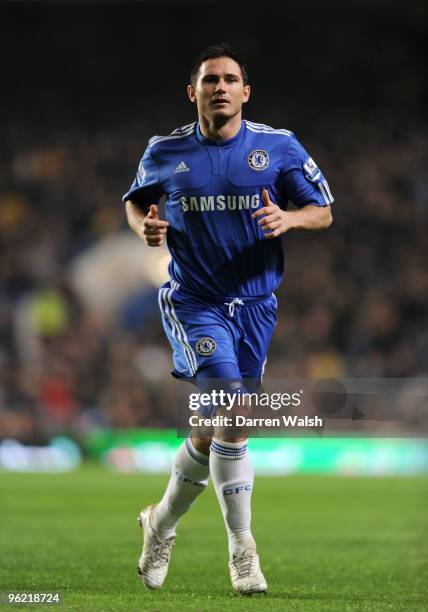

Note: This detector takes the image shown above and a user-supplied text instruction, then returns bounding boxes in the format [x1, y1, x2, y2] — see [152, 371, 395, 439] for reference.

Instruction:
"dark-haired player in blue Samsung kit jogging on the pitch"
[123, 44, 333, 594]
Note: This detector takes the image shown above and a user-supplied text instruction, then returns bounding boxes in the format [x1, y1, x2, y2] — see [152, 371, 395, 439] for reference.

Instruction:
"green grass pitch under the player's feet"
[0, 466, 428, 612]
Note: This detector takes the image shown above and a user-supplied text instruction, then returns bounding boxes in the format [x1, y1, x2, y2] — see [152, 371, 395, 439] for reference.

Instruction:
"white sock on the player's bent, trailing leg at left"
[151, 438, 210, 538]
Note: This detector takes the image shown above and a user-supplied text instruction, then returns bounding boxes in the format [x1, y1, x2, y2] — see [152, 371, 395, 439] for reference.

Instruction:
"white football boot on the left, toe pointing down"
[138, 505, 175, 589]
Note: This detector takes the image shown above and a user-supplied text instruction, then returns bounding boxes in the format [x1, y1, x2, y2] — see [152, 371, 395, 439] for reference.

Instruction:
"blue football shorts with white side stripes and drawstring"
[159, 281, 277, 379]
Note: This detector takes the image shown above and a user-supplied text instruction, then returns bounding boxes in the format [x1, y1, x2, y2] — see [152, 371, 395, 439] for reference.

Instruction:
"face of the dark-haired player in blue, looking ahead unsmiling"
[187, 57, 250, 120]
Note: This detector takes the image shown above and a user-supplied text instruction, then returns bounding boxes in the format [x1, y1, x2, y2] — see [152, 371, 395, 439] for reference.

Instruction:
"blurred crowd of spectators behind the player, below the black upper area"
[0, 115, 428, 442]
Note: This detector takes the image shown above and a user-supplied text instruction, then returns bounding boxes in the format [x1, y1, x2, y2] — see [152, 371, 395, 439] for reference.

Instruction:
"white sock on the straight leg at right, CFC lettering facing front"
[210, 438, 256, 557]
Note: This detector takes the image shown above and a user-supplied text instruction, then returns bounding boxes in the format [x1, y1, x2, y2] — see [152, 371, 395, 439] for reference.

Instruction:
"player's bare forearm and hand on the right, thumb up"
[252, 189, 333, 238]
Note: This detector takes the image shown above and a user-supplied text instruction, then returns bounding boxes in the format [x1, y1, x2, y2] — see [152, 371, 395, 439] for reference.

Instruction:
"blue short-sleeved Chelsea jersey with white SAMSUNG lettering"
[123, 121, 333, 297]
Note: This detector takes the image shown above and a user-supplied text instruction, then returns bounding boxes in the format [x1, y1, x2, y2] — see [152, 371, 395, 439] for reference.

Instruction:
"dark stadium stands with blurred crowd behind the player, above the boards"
[0, 1, 428, 450]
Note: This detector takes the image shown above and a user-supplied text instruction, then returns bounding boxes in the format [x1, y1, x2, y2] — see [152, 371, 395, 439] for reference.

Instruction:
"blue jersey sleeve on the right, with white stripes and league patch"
[280, 134, 334, 208]
